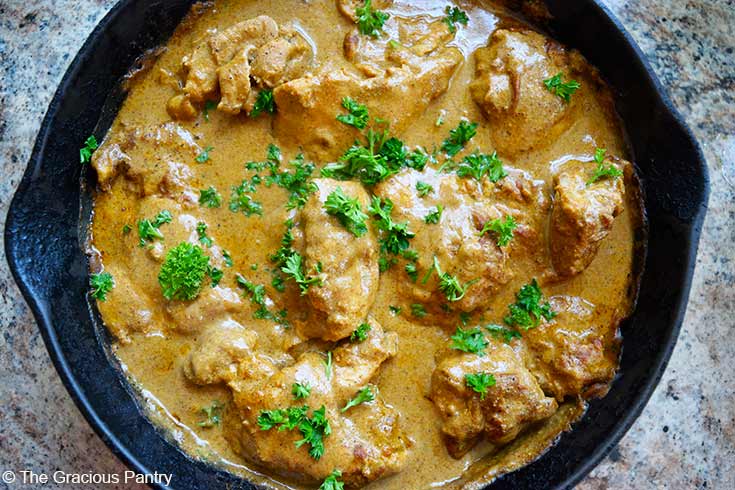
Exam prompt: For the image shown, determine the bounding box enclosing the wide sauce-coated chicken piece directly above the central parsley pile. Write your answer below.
[273,33,462,161]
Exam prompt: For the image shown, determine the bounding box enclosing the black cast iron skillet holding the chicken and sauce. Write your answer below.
[5,0,709,489]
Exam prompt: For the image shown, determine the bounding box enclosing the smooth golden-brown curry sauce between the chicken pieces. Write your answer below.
[92,0,641,489]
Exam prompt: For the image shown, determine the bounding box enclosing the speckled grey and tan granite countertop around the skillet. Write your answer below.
[0,0,735,489]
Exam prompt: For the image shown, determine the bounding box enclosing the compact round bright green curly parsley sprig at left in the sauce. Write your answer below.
[158,242,209,301]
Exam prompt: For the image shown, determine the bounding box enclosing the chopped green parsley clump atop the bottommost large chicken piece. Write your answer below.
[258,405,332,460]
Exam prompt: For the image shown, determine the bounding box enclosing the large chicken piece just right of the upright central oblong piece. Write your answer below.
[374,167,548,316]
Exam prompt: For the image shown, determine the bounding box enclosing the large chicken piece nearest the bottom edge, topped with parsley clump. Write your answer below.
[225,319,409,485]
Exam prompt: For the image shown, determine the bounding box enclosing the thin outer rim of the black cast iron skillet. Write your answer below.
[4,0,710,488]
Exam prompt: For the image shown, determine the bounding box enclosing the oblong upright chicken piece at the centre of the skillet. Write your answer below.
[298,179,379,341]
